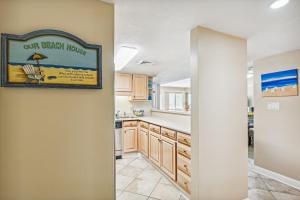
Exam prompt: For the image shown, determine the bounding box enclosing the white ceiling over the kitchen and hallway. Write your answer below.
[112,0,300,82]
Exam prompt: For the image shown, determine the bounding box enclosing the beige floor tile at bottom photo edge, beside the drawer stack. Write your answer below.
[150,183,181,200]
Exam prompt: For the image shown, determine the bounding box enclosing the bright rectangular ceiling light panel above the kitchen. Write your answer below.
[114,46,138,71]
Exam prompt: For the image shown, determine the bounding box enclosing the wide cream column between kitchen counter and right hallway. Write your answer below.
[191,27,248,200]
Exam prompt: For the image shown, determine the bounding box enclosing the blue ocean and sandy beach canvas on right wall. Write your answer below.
[261,69,298,97]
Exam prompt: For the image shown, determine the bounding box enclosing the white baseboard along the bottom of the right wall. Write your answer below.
[253,165,300,190]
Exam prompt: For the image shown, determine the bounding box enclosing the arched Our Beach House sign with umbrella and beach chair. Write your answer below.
[1,30,102,89]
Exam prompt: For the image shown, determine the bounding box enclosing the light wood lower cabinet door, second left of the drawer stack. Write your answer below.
[149,131,161,167]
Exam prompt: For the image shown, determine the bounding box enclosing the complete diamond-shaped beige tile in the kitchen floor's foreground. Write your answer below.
[125,179,158,196]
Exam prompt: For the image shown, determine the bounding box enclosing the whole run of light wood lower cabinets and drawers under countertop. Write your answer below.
[123,120,192,194]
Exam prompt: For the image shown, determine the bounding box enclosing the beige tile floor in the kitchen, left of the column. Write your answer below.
[116,153,187,200]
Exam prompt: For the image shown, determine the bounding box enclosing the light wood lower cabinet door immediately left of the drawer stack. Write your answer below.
[161,136,176,180]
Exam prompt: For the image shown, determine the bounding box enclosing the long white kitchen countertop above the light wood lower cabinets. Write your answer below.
[118,116,191,134]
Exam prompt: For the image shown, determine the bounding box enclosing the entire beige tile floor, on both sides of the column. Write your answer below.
[116,153,300,200]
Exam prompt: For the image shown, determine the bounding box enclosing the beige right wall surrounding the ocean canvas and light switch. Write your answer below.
[254,50,300,181]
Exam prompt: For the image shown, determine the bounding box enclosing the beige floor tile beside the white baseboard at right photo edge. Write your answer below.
[262,179,300,196]
